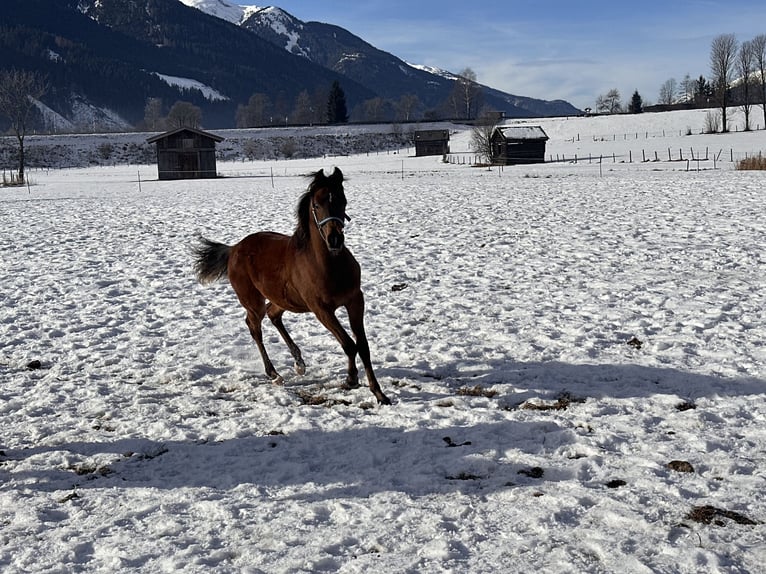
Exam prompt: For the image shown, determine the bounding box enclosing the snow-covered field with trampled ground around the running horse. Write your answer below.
[0,110,766,574]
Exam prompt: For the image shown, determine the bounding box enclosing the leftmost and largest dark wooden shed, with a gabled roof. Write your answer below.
[146,128,223,179]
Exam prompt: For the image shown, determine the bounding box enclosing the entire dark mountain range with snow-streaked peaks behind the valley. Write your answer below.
[0,0,577,130]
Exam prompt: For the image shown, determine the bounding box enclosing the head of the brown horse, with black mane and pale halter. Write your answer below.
[306,167,351,255]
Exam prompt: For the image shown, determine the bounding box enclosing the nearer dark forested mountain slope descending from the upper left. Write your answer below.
[0,0,375,127]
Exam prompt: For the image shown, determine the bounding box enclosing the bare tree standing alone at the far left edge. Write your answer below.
[0,70,48,183]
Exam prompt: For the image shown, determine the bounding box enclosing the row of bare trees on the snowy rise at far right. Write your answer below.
[596,34,766,132]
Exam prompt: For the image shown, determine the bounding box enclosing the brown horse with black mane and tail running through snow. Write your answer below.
[194,167,391,405]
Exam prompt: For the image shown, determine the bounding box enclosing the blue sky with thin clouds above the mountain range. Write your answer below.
[239,0,766,109]
